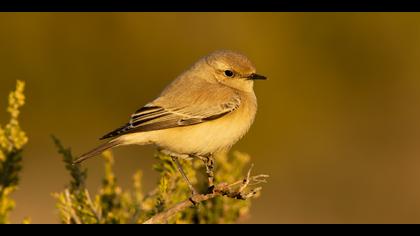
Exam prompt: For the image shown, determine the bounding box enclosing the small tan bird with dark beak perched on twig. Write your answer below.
[75,50,266,193]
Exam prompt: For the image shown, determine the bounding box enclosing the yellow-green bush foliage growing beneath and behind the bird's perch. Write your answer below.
[54,136,256,224]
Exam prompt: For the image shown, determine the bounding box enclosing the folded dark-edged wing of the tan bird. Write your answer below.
[101,93,241,139]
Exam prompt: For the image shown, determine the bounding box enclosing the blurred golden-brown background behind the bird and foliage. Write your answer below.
[0,13,420,223]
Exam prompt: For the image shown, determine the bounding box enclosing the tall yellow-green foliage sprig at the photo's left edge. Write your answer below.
[0,81,28,224]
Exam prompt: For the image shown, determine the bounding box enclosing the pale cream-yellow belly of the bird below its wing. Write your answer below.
[152,109,255,155]
